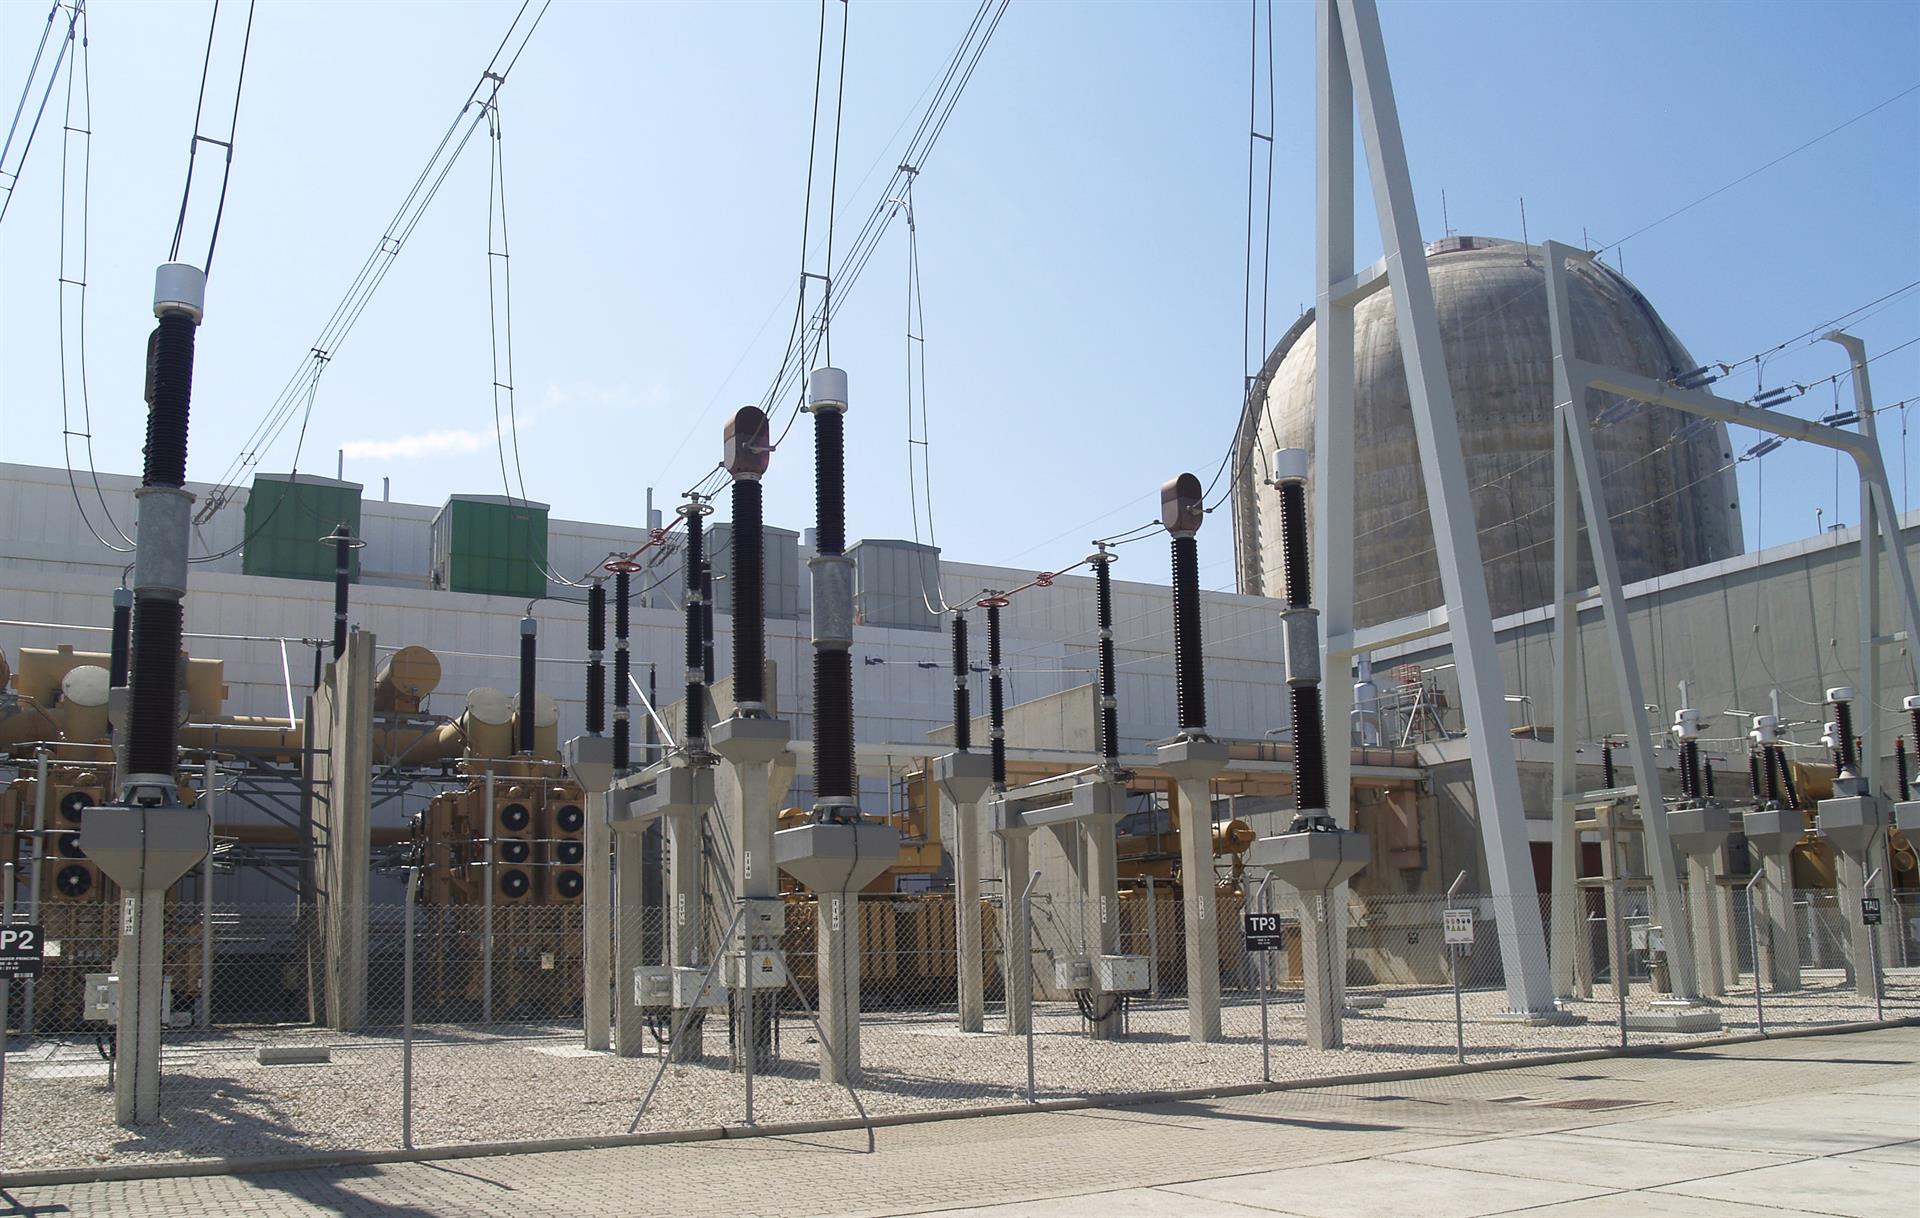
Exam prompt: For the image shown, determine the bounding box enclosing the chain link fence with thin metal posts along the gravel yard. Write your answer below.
[0,882,1920,1170]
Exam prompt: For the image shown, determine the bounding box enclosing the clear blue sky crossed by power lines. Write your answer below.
[0,0,1920,588]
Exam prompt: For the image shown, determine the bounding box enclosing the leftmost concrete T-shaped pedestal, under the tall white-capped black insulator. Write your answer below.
[78,805,211,1126]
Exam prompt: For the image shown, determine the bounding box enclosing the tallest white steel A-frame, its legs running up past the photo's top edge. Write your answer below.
[1313,0,1553,1014]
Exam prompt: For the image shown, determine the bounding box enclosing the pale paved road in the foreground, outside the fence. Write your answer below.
[0,1028,1920,1218]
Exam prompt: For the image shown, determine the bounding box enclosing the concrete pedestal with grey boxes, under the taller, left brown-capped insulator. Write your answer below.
[710,715,793,1070]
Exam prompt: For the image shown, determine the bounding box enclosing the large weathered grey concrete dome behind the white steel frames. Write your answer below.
[1235,236,1743,626]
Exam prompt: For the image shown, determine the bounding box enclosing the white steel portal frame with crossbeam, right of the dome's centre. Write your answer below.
[1546,242,1920,993]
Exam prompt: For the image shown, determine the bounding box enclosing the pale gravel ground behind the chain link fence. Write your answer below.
[0,970,1920,1170]
